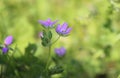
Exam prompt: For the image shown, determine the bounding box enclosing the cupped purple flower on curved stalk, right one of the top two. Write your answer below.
[56,23,72,36]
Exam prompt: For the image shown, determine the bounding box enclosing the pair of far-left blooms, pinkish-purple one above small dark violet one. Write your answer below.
[2,36,13,53]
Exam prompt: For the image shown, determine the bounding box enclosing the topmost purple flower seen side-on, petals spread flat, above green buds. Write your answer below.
[38,18,57,28]
